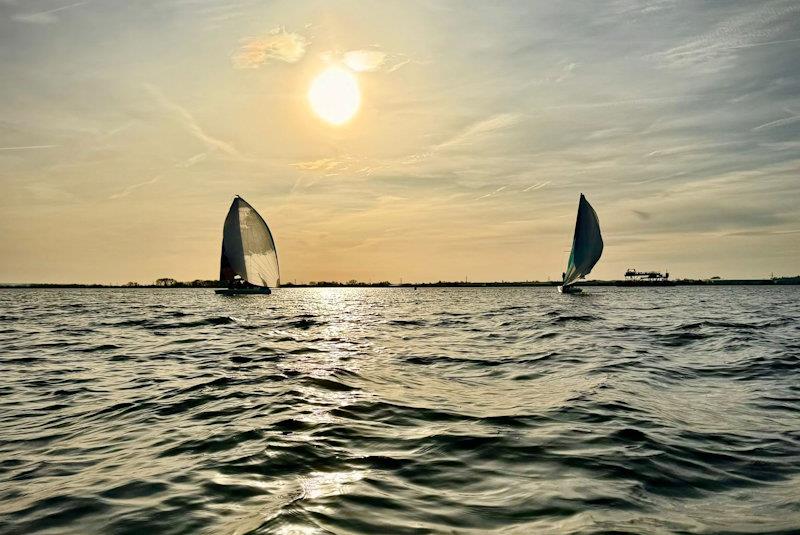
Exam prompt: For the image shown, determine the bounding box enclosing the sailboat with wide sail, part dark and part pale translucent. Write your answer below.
[216,195,281,295]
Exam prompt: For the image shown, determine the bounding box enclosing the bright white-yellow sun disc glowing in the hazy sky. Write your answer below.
[308,67,361,126]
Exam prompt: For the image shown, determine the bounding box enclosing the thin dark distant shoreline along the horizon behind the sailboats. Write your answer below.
[0,276,800,289]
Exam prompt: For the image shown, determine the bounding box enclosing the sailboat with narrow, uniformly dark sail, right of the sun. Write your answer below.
[558,193,603,293]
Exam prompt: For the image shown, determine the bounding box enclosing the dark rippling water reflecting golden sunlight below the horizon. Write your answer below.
[0,287,800,534]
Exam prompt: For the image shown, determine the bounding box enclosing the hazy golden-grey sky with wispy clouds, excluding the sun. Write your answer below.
[0,0,800,283]
